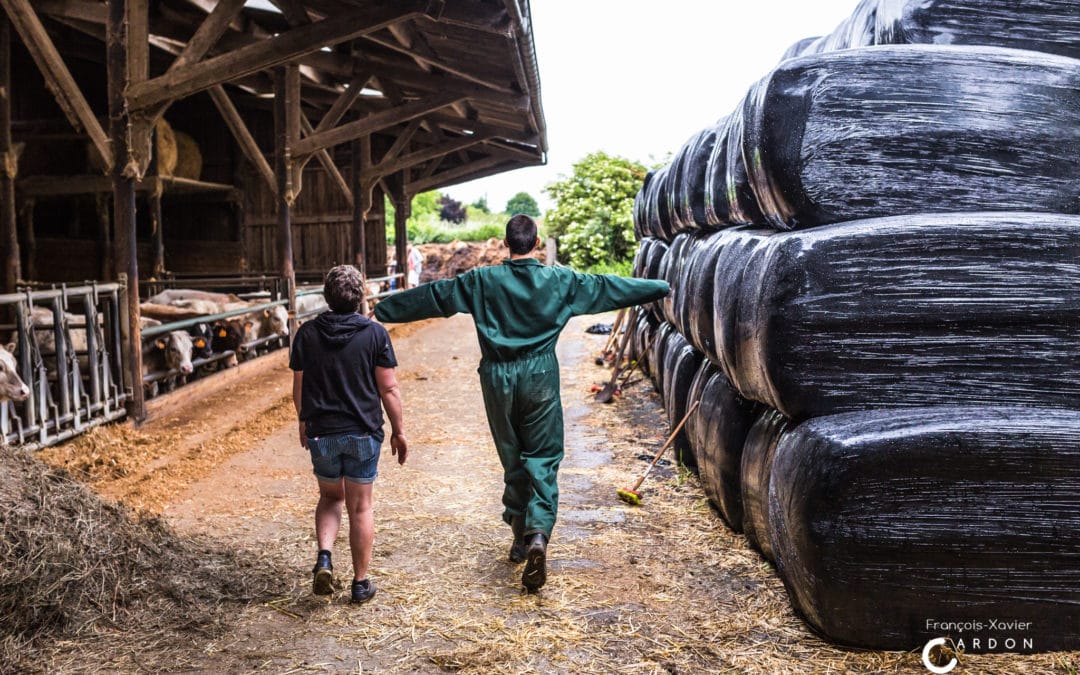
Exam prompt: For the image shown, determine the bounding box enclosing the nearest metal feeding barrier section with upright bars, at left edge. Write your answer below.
[0,283,127,447]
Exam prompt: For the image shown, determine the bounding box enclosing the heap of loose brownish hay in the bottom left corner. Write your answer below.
[0,447,280,672]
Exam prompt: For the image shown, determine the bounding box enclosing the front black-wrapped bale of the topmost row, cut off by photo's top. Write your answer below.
[875,0,1080,58]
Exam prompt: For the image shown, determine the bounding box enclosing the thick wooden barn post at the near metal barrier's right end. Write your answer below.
[106,0,146,423]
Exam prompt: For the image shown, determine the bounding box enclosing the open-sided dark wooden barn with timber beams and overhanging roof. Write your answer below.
[0,0,546,419]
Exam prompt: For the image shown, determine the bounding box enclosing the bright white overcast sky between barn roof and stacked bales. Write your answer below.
[442,0,858,211]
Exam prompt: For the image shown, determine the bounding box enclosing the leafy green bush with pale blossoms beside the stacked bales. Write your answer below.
[544,152,646,269]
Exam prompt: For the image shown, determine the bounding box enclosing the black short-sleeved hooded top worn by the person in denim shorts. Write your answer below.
[288,312,397,443]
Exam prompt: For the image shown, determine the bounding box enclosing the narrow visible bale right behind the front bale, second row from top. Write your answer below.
[704,104,765,229]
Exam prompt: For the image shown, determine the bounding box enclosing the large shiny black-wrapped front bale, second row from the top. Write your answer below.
[742,45,1080,229]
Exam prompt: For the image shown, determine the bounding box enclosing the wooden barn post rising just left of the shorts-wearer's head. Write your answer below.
[273,64,300,335]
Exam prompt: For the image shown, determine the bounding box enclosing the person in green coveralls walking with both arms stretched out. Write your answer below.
[375,214,669,592]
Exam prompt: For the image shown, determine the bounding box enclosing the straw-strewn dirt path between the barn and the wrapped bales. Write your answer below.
[78,316,1061,674]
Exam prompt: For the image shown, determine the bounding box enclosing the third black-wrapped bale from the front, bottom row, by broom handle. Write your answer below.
[687,361,762,532]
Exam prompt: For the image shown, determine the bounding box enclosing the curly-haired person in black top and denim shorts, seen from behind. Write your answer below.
[288,265,408,603]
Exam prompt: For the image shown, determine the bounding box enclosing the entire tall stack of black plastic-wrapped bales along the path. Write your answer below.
[634,0,1080,651]
